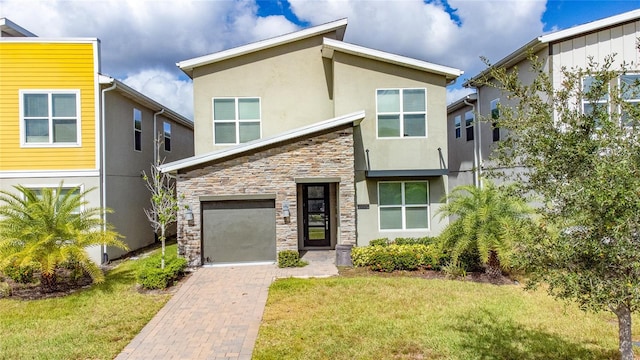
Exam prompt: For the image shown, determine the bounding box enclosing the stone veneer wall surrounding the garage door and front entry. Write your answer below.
[177,125,356,266]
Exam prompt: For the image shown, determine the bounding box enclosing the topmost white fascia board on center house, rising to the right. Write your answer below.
[176,19,347,74]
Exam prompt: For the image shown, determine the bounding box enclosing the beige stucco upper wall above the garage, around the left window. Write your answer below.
[193,33,335,155]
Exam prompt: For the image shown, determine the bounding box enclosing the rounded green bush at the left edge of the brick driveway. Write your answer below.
[136,256,187,289]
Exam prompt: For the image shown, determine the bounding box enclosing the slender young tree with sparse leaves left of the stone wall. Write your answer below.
[143,136,179,269]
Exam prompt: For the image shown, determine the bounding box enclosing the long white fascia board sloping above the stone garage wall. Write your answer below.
[160,111,365,173]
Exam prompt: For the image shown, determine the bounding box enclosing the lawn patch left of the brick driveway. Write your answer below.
[0,245,177,359]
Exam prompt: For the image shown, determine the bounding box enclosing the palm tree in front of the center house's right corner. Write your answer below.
[438,180,531,278]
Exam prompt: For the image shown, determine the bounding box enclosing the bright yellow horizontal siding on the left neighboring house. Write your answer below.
[0,42,97,171]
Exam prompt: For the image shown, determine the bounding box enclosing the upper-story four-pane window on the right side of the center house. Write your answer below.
[376,89,427,138]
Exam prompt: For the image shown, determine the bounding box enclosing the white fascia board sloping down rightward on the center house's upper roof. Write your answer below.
[322,38,464,79]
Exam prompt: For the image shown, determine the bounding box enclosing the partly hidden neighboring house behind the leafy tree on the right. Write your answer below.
[447,10,640,188]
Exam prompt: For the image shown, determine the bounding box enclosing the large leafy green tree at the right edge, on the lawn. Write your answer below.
[485,52,640,360]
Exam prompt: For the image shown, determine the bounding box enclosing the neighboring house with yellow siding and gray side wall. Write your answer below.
[0,19,193,263]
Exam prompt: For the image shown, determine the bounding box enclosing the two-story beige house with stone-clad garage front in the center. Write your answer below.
[163,20,462,265]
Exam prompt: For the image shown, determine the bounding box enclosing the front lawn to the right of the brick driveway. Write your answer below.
[253,277,640,360]
